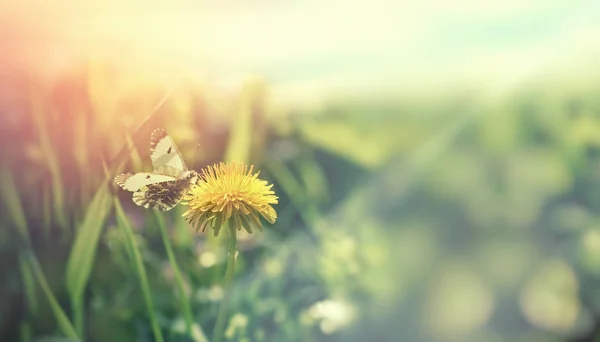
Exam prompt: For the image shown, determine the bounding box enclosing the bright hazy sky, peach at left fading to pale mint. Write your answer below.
[0,0,600,103]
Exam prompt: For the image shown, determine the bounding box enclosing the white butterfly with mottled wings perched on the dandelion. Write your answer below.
[115,128,198,211]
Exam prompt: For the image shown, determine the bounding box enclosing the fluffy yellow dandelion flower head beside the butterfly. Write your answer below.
[183,162,277,236]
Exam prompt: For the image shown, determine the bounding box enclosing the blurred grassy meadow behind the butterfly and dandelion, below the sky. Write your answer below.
[0,60,600,342]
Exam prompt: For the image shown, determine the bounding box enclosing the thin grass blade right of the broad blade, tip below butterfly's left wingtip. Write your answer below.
[114,196,163,342]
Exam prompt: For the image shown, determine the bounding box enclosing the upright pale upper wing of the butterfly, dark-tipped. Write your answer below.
[150,128,188,178]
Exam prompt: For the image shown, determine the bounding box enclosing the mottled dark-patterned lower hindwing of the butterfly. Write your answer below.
[133,179,190,211]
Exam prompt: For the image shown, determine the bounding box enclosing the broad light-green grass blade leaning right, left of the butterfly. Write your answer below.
[66,179,112,333]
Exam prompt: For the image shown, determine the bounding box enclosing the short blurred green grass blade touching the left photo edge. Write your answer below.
[0,168,31,244]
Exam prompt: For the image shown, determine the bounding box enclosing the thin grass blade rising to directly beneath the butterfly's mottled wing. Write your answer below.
[152,210,206,341]
